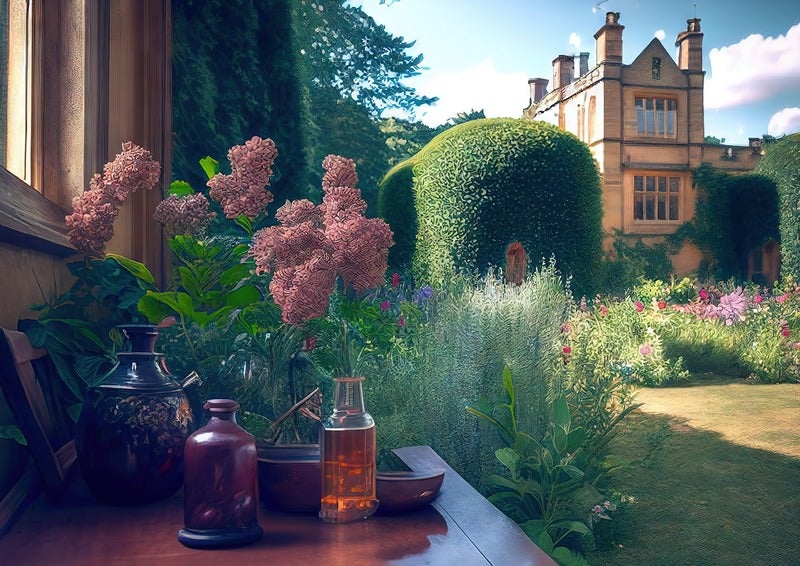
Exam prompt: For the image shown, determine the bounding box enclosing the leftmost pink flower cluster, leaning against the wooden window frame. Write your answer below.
[65,142,161,256]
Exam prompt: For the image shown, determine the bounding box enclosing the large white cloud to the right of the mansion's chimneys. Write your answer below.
[705,24,800,108]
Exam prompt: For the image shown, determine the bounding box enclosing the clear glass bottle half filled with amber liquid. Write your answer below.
[319,377,378,523]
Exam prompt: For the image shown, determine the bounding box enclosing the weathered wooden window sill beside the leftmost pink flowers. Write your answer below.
[0,167,76,256]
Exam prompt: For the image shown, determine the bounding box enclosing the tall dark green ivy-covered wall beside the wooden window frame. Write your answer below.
[172,0,314,202]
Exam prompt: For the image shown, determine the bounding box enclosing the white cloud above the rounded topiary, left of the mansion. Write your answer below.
[406,59,530,127]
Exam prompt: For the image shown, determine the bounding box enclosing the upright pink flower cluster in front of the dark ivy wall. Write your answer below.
[207,136,278,219]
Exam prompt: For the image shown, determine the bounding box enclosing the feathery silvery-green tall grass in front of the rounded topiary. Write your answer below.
[366,265,569,485]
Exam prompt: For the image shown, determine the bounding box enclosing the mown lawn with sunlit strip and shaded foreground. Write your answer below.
[587,379,800,566]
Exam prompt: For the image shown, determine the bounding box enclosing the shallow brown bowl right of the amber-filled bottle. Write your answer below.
[376,470,444,514]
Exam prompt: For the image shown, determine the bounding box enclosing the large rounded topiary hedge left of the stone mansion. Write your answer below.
[384,118,602,293]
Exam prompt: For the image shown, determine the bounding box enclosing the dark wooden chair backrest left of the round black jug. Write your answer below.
[0,329,76,495]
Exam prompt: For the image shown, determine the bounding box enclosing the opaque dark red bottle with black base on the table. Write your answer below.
[178,399,263,548]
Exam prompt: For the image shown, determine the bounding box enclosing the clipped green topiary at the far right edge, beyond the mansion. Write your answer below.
[756,133,800,281]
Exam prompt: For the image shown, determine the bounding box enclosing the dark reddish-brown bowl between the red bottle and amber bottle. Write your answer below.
[258,444,322,513]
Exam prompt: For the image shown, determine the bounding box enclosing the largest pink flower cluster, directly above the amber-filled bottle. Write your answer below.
[250,155,394,324]
